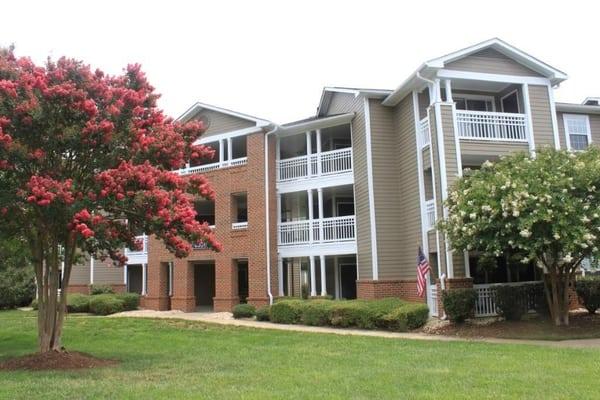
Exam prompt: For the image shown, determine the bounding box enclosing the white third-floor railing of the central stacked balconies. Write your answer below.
[277,147,352,182]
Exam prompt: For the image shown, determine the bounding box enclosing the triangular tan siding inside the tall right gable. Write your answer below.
[444,49,541,76]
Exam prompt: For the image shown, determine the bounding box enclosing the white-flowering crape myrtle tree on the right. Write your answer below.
[440,148,600,325]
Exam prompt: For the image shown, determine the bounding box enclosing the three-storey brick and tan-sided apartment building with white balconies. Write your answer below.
[70,39,600,315]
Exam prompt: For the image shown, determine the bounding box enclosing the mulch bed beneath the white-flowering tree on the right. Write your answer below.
[422,310,600,340]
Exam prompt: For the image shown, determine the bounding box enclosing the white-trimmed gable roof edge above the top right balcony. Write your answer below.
[383,38,568,106]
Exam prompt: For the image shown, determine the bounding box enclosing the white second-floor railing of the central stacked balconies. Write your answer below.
[278,215,356,246]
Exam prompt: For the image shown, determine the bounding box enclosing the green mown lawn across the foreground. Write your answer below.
[0,311,600,399]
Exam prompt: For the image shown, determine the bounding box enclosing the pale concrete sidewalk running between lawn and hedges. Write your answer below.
[110,310,600,349]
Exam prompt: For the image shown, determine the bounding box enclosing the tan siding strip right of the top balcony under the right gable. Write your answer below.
[529,85,554,149]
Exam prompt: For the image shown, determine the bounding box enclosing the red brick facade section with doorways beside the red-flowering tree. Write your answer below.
[142,133,277,311]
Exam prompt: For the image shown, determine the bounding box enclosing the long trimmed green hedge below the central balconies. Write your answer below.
[269,298,429,331]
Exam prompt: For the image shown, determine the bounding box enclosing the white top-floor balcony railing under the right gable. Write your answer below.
[456,110,527,142]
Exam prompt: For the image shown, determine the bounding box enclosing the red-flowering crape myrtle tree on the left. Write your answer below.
[0,49,220,352]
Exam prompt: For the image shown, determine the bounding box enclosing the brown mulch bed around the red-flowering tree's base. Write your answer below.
[0,351,119,371]
